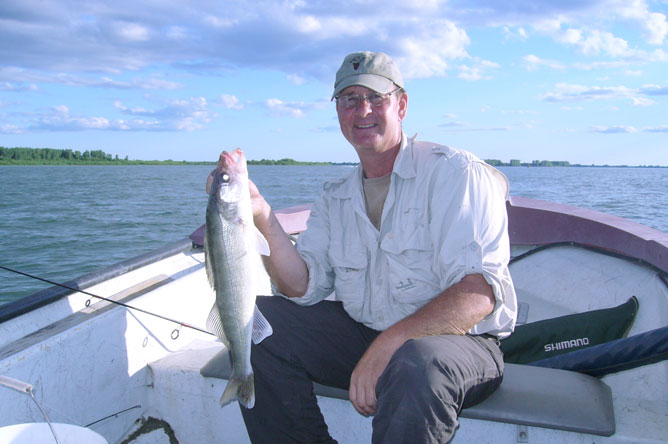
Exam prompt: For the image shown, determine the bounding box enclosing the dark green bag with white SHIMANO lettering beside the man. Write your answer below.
[501,296,638,364]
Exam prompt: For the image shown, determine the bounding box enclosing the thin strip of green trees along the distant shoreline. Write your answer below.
[0,146,668,168]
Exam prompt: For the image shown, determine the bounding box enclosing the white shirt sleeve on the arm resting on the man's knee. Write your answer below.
[430,161,517,337]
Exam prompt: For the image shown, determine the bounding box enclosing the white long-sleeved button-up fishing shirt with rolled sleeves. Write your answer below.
[282,134,517,338]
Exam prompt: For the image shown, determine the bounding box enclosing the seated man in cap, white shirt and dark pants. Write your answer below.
[209,52,517,444]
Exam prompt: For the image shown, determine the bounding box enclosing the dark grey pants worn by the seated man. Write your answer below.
[241,296,503,444]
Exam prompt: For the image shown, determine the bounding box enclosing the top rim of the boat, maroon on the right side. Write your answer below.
[5,196,668,323]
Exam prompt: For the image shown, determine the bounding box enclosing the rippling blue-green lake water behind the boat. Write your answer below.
[0,165,668,303]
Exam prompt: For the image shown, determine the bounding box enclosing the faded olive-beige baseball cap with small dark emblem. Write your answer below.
[332,51,404,99]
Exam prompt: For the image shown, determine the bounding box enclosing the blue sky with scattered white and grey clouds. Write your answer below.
[0,0,668,166]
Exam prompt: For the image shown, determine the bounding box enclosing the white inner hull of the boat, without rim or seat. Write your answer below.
[0,199,668,444]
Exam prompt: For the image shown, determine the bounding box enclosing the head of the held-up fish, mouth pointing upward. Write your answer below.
[211,148,250,219]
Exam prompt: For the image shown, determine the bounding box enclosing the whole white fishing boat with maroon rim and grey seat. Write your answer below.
[0,196,668,444]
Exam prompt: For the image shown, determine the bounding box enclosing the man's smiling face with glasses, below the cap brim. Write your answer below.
[336,86,408,154]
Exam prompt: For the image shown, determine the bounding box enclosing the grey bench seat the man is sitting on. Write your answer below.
[200,349,615,436]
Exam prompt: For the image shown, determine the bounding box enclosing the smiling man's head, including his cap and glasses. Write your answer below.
[333,52,408,158]
